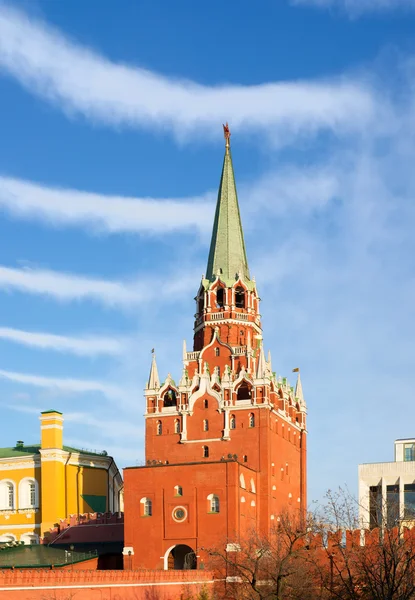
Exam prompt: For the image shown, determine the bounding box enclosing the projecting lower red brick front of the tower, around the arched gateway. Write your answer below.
[124,462,239,569]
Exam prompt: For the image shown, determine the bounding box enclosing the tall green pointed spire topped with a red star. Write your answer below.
[206,124,250,281]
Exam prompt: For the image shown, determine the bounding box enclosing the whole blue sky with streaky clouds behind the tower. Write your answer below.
[0,0,415,500]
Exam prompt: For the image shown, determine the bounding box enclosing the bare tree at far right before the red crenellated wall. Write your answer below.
[310,489,415,600]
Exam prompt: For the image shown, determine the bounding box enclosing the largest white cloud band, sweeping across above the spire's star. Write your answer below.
[0,4,375,140]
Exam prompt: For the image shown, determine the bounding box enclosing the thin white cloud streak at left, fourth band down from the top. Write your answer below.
[0,327,127,356]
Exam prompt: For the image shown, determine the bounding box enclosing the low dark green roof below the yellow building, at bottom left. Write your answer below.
[0,544,96,569]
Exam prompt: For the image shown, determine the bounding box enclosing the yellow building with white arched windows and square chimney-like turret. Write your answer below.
[0,410,123,544]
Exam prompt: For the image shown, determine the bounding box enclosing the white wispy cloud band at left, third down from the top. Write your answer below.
[0,266,197,308]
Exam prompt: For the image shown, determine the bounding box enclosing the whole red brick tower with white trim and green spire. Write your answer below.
[124,126,306,568]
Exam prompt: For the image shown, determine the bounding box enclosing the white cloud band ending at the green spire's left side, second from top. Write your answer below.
[0,176,213,234]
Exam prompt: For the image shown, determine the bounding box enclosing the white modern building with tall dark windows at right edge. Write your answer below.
[359,438,415,529]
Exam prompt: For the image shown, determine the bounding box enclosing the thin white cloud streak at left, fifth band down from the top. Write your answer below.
[0,370,126,398]
